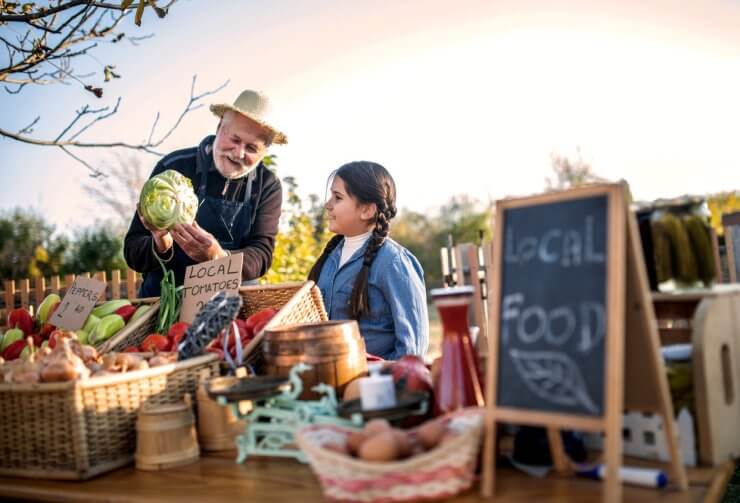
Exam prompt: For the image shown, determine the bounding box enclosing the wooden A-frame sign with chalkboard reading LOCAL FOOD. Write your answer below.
[482,184,686,501]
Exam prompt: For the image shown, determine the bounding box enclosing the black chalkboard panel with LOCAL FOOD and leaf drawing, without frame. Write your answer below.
[497,195,608,416]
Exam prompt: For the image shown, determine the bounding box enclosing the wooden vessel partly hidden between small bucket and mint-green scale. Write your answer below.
[196,384,247,451]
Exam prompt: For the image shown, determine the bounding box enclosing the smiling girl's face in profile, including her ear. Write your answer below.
[325,176,377,237]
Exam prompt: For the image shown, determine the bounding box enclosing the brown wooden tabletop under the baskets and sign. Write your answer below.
[0,452,734,503]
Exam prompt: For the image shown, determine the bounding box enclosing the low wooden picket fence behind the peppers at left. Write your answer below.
[0,269,141,327]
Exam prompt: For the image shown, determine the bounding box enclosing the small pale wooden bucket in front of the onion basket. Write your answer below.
[135,395,200,470]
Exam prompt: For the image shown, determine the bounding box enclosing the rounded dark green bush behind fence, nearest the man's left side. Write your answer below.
[62,225,126,274]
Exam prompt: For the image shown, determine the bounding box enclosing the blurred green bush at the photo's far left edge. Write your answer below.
[0,208,69,279]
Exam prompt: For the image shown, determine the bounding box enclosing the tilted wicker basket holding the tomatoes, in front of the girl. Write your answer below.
[239,281,329,370]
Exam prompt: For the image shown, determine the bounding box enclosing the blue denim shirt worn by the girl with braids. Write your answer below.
[317,238,429,360]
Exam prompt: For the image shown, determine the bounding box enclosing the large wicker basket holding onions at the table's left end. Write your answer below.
[0,354,218,480]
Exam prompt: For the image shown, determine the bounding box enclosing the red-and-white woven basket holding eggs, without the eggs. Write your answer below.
[296,408,483,503]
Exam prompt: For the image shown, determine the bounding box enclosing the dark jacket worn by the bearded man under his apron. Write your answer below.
[123,136,283,285]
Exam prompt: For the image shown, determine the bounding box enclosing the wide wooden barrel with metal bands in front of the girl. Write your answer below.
[262,320,367,400]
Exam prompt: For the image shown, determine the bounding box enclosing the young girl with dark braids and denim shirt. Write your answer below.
[308,161,429,360]
